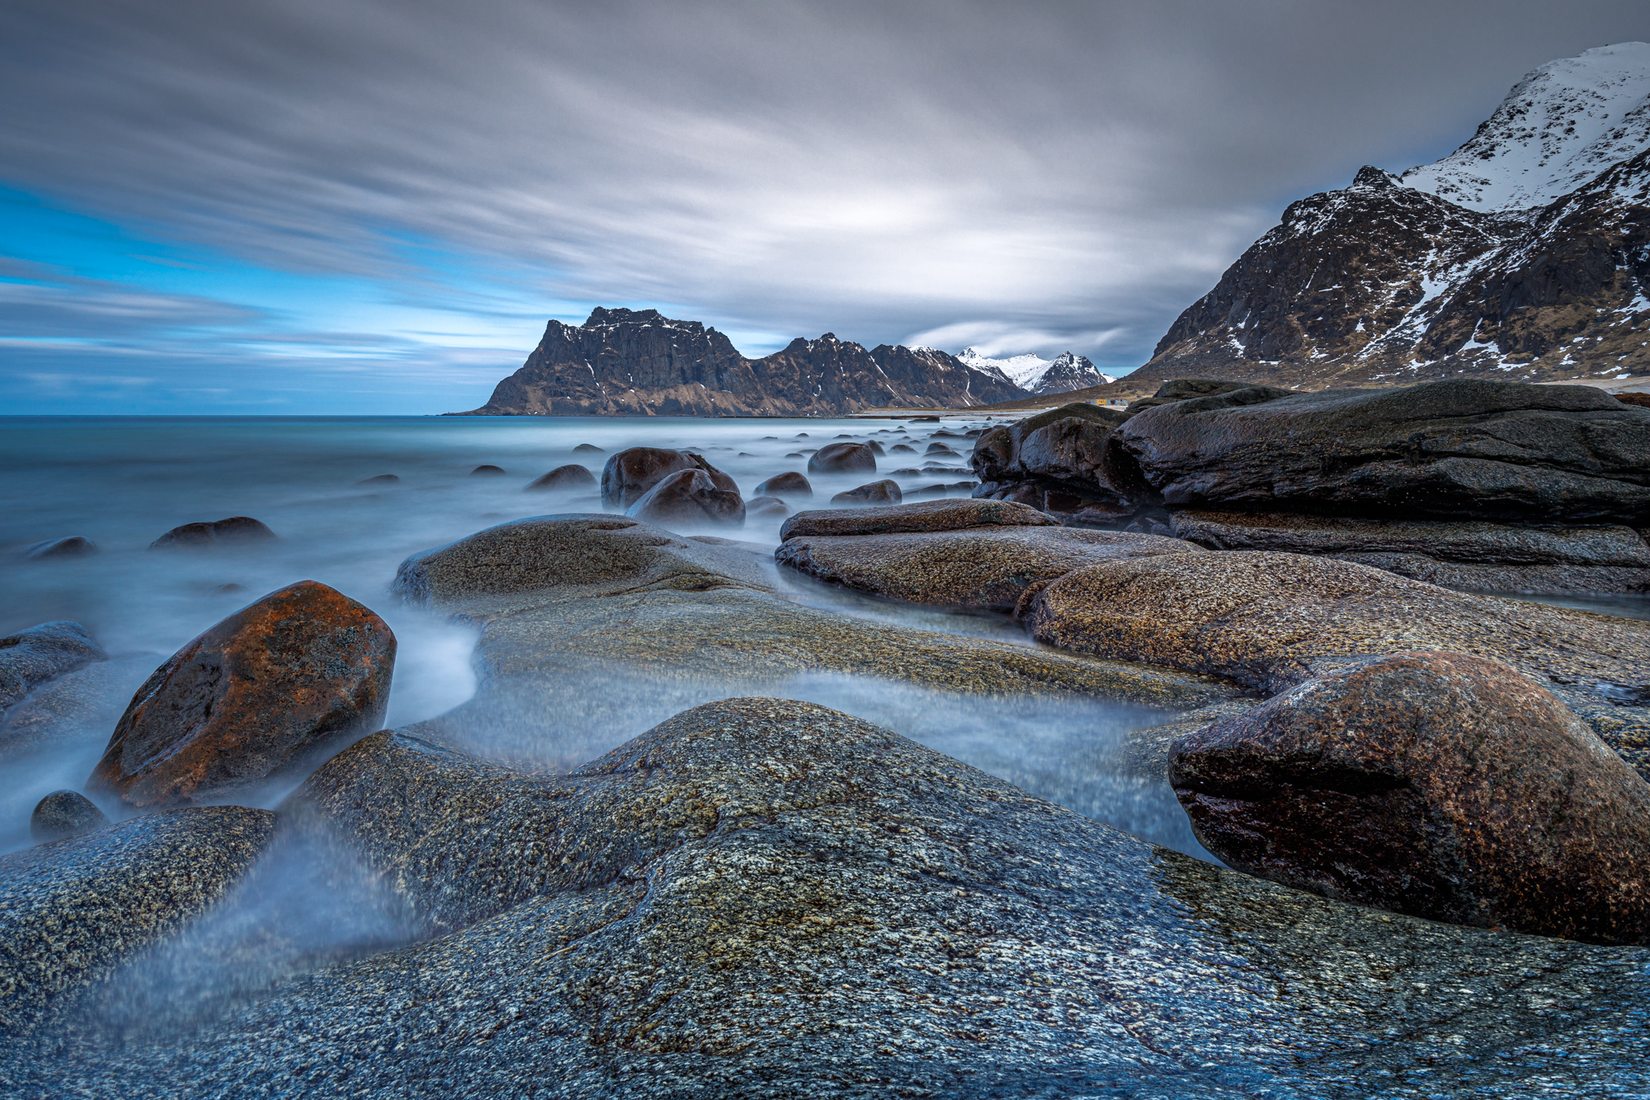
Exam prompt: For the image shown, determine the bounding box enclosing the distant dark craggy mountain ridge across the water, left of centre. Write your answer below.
[472,308,1025,416]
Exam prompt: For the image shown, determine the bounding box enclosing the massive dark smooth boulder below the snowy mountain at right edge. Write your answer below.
[1112,379,1650,524]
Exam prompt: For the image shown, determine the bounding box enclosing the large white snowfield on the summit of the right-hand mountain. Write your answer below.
[1399,41,1650,213]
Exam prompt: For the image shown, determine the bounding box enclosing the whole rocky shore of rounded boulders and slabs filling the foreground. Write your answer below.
[0,381,1650,1097]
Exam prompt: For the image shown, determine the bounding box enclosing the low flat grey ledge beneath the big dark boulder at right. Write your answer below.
[1172,510,1650,592]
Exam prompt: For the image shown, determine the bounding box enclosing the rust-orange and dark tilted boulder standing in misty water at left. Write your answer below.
[89,581,396,806]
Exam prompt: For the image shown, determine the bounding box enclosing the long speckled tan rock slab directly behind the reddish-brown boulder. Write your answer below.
[1025,551,1650,775]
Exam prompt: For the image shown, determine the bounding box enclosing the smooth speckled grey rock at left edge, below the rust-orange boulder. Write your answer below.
[0,806,274,1046]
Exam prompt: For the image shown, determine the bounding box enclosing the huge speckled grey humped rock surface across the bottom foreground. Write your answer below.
[12,699,1650,1097]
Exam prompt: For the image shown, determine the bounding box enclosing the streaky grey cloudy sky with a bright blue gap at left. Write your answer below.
[0,0,1650,414]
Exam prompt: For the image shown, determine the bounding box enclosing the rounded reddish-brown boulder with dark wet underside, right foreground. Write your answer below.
[1170,653,1650,943]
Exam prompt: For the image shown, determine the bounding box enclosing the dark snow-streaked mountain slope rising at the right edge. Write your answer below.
[1129,43,1650,388]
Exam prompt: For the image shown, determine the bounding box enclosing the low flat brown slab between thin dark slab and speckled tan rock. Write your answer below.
[774,524,1198,612]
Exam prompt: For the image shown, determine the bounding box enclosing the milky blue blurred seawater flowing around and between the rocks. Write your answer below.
[0,410,1206,1032]
